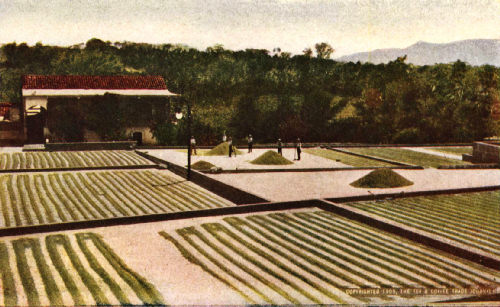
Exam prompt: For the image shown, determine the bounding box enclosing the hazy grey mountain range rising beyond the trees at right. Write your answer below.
[335,39,500,67]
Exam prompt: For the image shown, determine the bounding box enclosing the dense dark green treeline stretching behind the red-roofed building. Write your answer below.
[0,39,500,143]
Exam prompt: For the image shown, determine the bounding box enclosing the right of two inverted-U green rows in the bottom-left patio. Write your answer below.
[45,234,110,305]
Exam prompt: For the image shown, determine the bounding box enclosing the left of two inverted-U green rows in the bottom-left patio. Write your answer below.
[12,238,63,306]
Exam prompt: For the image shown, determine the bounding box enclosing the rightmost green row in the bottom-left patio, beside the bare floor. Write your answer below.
[78,233,164,305]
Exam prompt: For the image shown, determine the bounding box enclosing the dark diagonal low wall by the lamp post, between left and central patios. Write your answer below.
[136,150,268,205]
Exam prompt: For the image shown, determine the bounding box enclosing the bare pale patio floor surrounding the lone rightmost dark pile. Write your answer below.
[205,169,500,201]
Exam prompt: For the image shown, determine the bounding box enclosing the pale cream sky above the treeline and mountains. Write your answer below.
[0,0,500,57]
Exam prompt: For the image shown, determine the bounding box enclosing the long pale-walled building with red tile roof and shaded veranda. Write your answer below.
[22,75,180,143]
